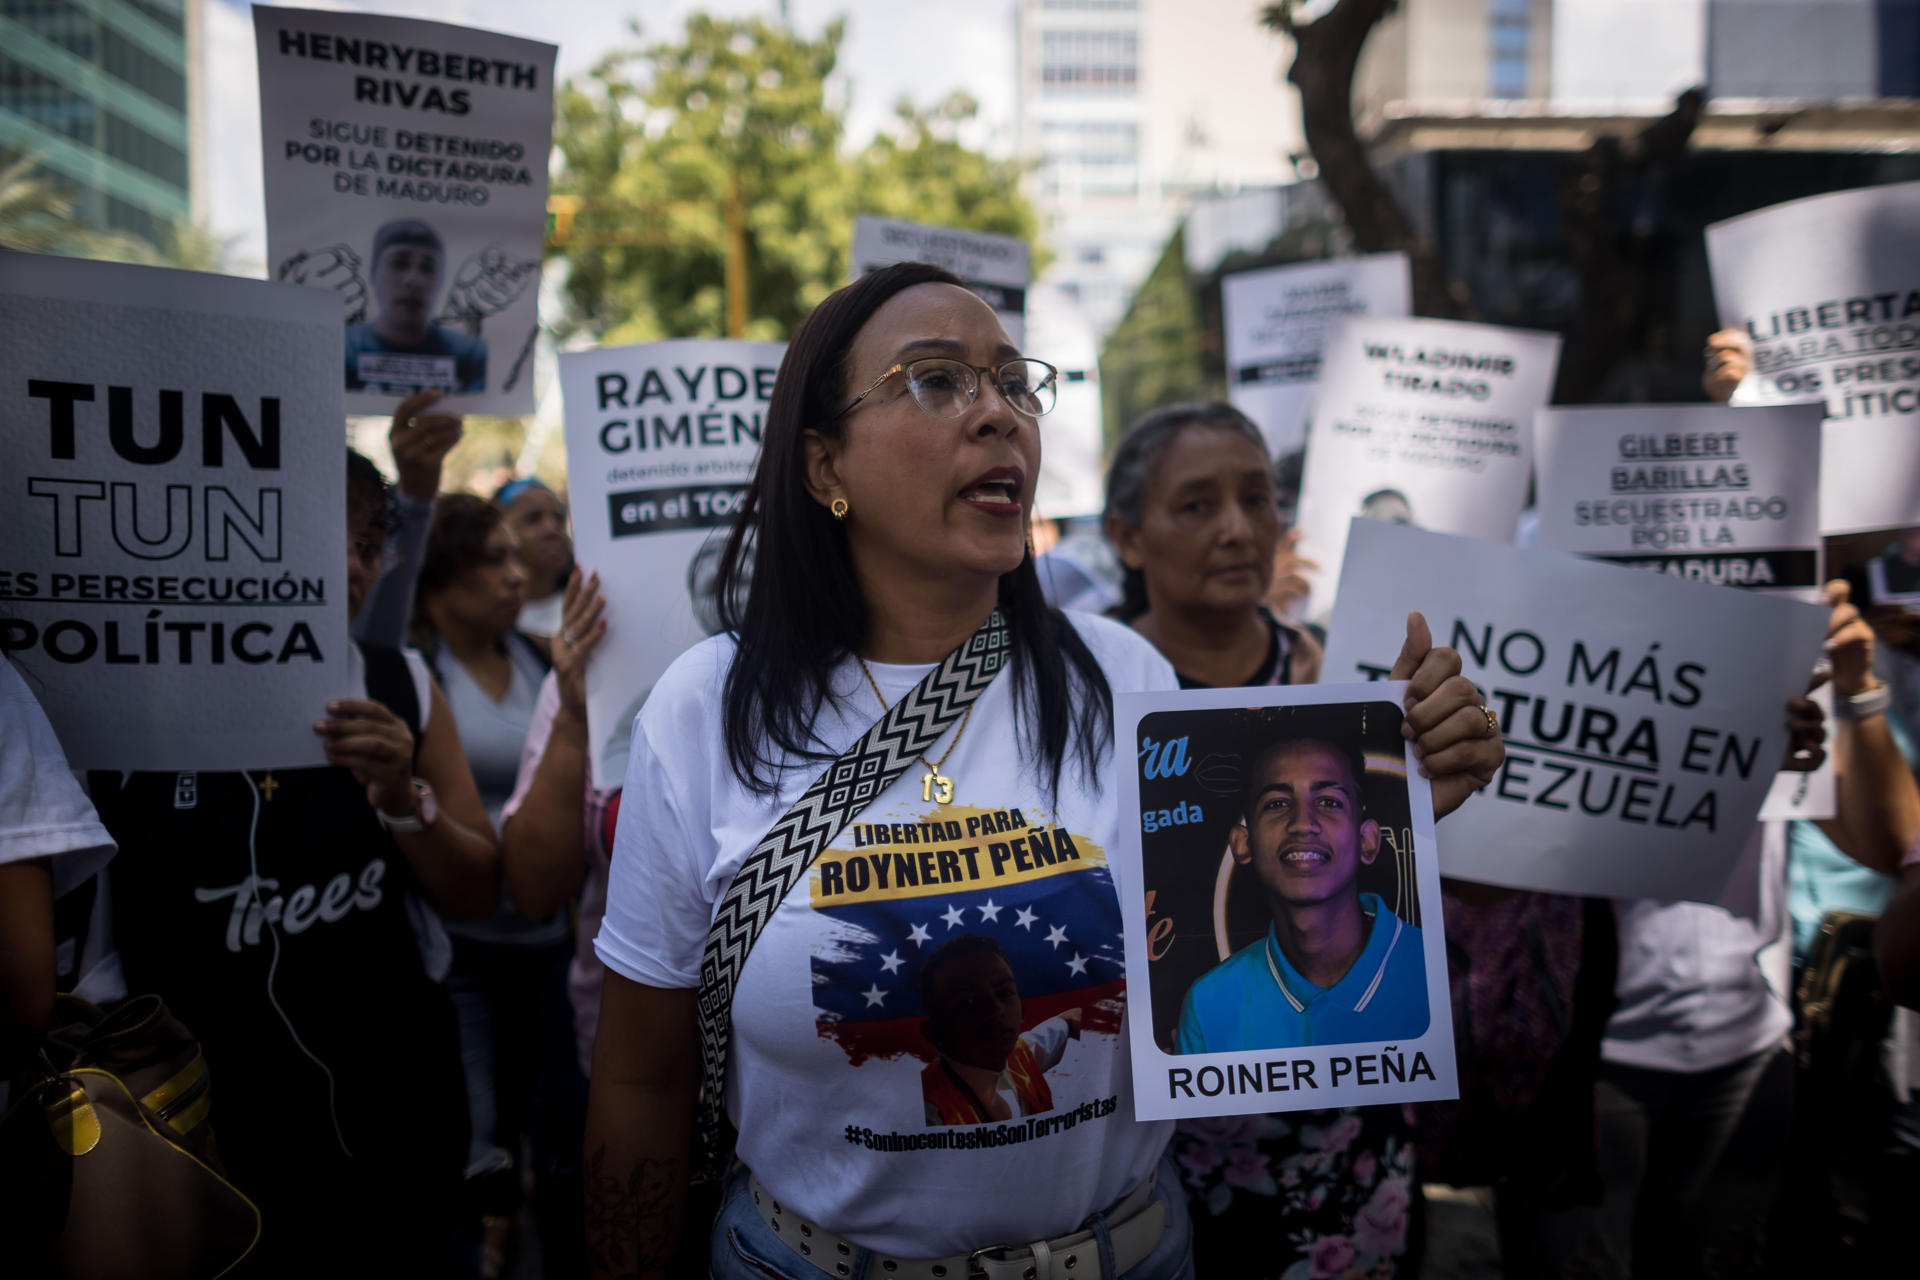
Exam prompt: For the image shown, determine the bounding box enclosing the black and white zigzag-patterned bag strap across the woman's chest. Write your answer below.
[693,608,1008,1176]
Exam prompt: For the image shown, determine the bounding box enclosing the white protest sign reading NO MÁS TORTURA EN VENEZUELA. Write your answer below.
[1325,520,1828,902]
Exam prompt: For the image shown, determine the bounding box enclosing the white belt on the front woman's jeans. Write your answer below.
[747,1174,1167,1280]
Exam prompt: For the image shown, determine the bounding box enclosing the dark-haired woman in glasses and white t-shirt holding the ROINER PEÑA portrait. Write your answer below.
[588,263,1484,1280]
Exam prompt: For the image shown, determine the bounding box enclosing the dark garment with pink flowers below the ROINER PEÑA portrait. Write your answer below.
[1173,1105,1419,1280]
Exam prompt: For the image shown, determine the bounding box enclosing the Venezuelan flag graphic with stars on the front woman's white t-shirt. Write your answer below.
[808,806,1125,1125]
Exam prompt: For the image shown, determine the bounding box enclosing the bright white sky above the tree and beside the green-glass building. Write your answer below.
[204,0,1016,274]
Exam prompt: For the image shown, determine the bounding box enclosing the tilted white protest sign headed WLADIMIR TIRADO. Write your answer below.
[1300,319,1559,618]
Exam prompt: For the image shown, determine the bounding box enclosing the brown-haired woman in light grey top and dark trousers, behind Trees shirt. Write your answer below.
[413,493,586,1276]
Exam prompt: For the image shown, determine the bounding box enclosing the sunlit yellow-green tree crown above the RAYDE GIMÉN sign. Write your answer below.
[549,15,1037,342]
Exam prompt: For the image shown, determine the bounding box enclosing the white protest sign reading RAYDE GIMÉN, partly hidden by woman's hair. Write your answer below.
[561,340,785,787]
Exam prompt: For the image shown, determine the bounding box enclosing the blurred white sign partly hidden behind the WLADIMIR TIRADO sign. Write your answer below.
[1219,253,1413,455]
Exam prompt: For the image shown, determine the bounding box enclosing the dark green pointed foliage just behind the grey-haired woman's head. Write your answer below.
[1100,226,1223,445]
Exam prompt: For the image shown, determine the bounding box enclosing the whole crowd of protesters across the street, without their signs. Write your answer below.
[0,265,1920,1280]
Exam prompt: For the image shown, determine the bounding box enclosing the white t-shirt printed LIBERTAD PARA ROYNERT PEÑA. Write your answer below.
[595,614,1177,1257]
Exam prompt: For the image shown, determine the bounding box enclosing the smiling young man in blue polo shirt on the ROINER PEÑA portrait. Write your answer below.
[1179,737,1430,1054]
